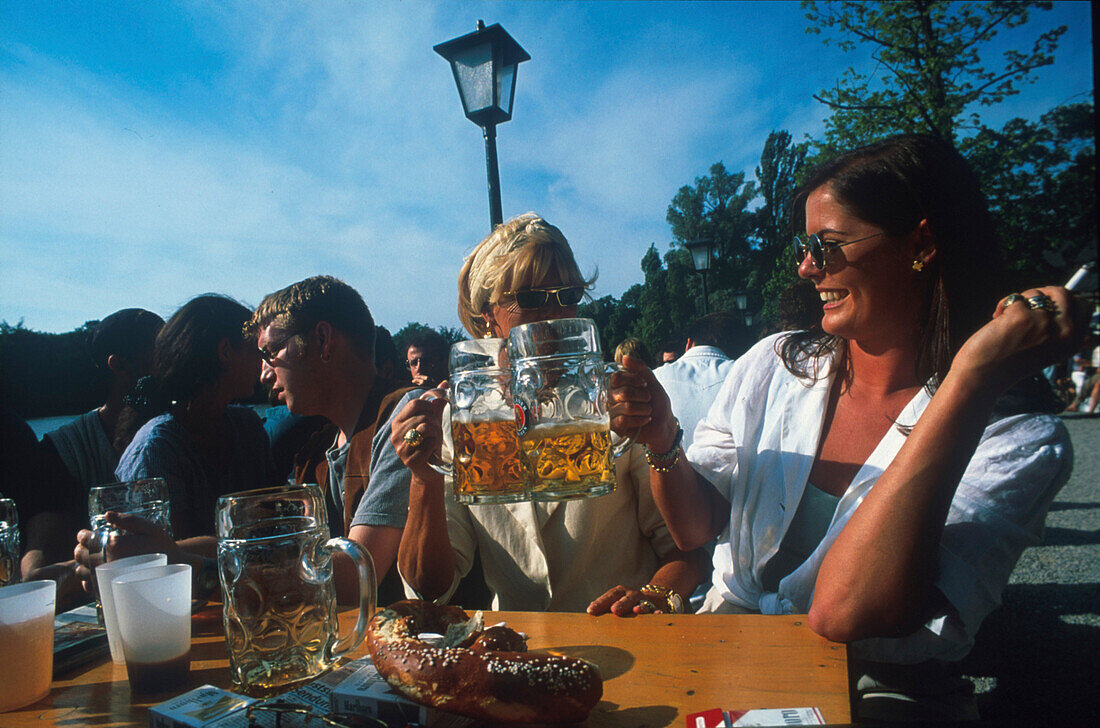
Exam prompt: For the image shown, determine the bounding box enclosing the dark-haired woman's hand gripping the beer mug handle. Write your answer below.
[608,355,677,452]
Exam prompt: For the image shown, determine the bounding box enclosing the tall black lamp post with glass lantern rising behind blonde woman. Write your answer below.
[433,20,531,230]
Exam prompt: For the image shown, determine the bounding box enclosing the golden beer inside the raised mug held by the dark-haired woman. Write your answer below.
[519,420,615,500]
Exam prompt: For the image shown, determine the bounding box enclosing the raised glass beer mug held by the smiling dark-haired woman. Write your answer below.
[508,319,633,500]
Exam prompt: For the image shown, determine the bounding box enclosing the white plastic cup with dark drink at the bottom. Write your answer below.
[111,564,191,694]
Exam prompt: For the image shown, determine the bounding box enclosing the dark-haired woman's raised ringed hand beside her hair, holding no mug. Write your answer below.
[952,286,1088,390]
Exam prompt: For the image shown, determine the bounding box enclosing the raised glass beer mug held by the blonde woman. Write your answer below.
[432,339,528,505]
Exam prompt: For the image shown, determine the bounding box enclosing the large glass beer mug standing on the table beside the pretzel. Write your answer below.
[216,485,375,695]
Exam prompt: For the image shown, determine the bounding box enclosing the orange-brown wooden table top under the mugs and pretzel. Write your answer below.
[0,611,850,728]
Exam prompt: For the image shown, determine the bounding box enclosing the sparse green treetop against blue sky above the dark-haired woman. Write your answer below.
[802,0,1066,151]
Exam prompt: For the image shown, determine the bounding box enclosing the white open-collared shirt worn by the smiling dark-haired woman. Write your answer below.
[688,334,1073,663]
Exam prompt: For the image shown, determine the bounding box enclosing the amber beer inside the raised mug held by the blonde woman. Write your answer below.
[451,417,527,504]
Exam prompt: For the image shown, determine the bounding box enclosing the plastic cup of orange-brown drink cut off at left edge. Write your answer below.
[0,581,57,713]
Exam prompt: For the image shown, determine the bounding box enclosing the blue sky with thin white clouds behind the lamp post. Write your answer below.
[0,0,1093,332]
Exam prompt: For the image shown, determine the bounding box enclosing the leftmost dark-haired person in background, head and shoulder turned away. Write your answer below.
[45,308,164,489]
